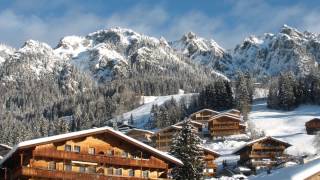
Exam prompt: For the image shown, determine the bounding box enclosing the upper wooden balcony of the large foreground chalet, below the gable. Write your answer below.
[32,149,167,169]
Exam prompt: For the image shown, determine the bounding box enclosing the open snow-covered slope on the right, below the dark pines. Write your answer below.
[249,101,320,155]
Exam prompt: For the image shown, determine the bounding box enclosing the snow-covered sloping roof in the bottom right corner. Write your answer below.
[250,157,320,180]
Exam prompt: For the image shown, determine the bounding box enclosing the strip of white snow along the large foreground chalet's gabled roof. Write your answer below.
[0,127,183,166]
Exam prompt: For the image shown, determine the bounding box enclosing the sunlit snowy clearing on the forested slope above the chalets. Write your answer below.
[123,90,194,128]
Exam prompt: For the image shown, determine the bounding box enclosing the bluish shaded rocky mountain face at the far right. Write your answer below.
[232,25,320,78]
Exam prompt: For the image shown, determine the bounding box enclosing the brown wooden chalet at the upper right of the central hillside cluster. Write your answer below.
[208,113,245,137]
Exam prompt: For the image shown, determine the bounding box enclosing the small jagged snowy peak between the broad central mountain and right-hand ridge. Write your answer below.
[170,32,232,72]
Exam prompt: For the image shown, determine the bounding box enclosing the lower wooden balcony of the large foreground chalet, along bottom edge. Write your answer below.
[13,167,166,180]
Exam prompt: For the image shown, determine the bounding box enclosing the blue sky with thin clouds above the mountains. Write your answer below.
[0,0,320,49]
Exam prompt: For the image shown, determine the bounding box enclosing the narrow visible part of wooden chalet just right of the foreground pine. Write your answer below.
[202,147,221,178]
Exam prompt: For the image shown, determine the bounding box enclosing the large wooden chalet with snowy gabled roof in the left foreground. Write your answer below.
[0,127,182,180]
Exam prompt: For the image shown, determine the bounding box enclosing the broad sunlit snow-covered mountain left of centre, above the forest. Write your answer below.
[55,28,225,81]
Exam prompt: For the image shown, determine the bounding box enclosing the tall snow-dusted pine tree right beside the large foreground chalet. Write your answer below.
[170,120,204,180]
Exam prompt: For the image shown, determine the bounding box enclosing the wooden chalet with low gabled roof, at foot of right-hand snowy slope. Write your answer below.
[234,136,291,168]
